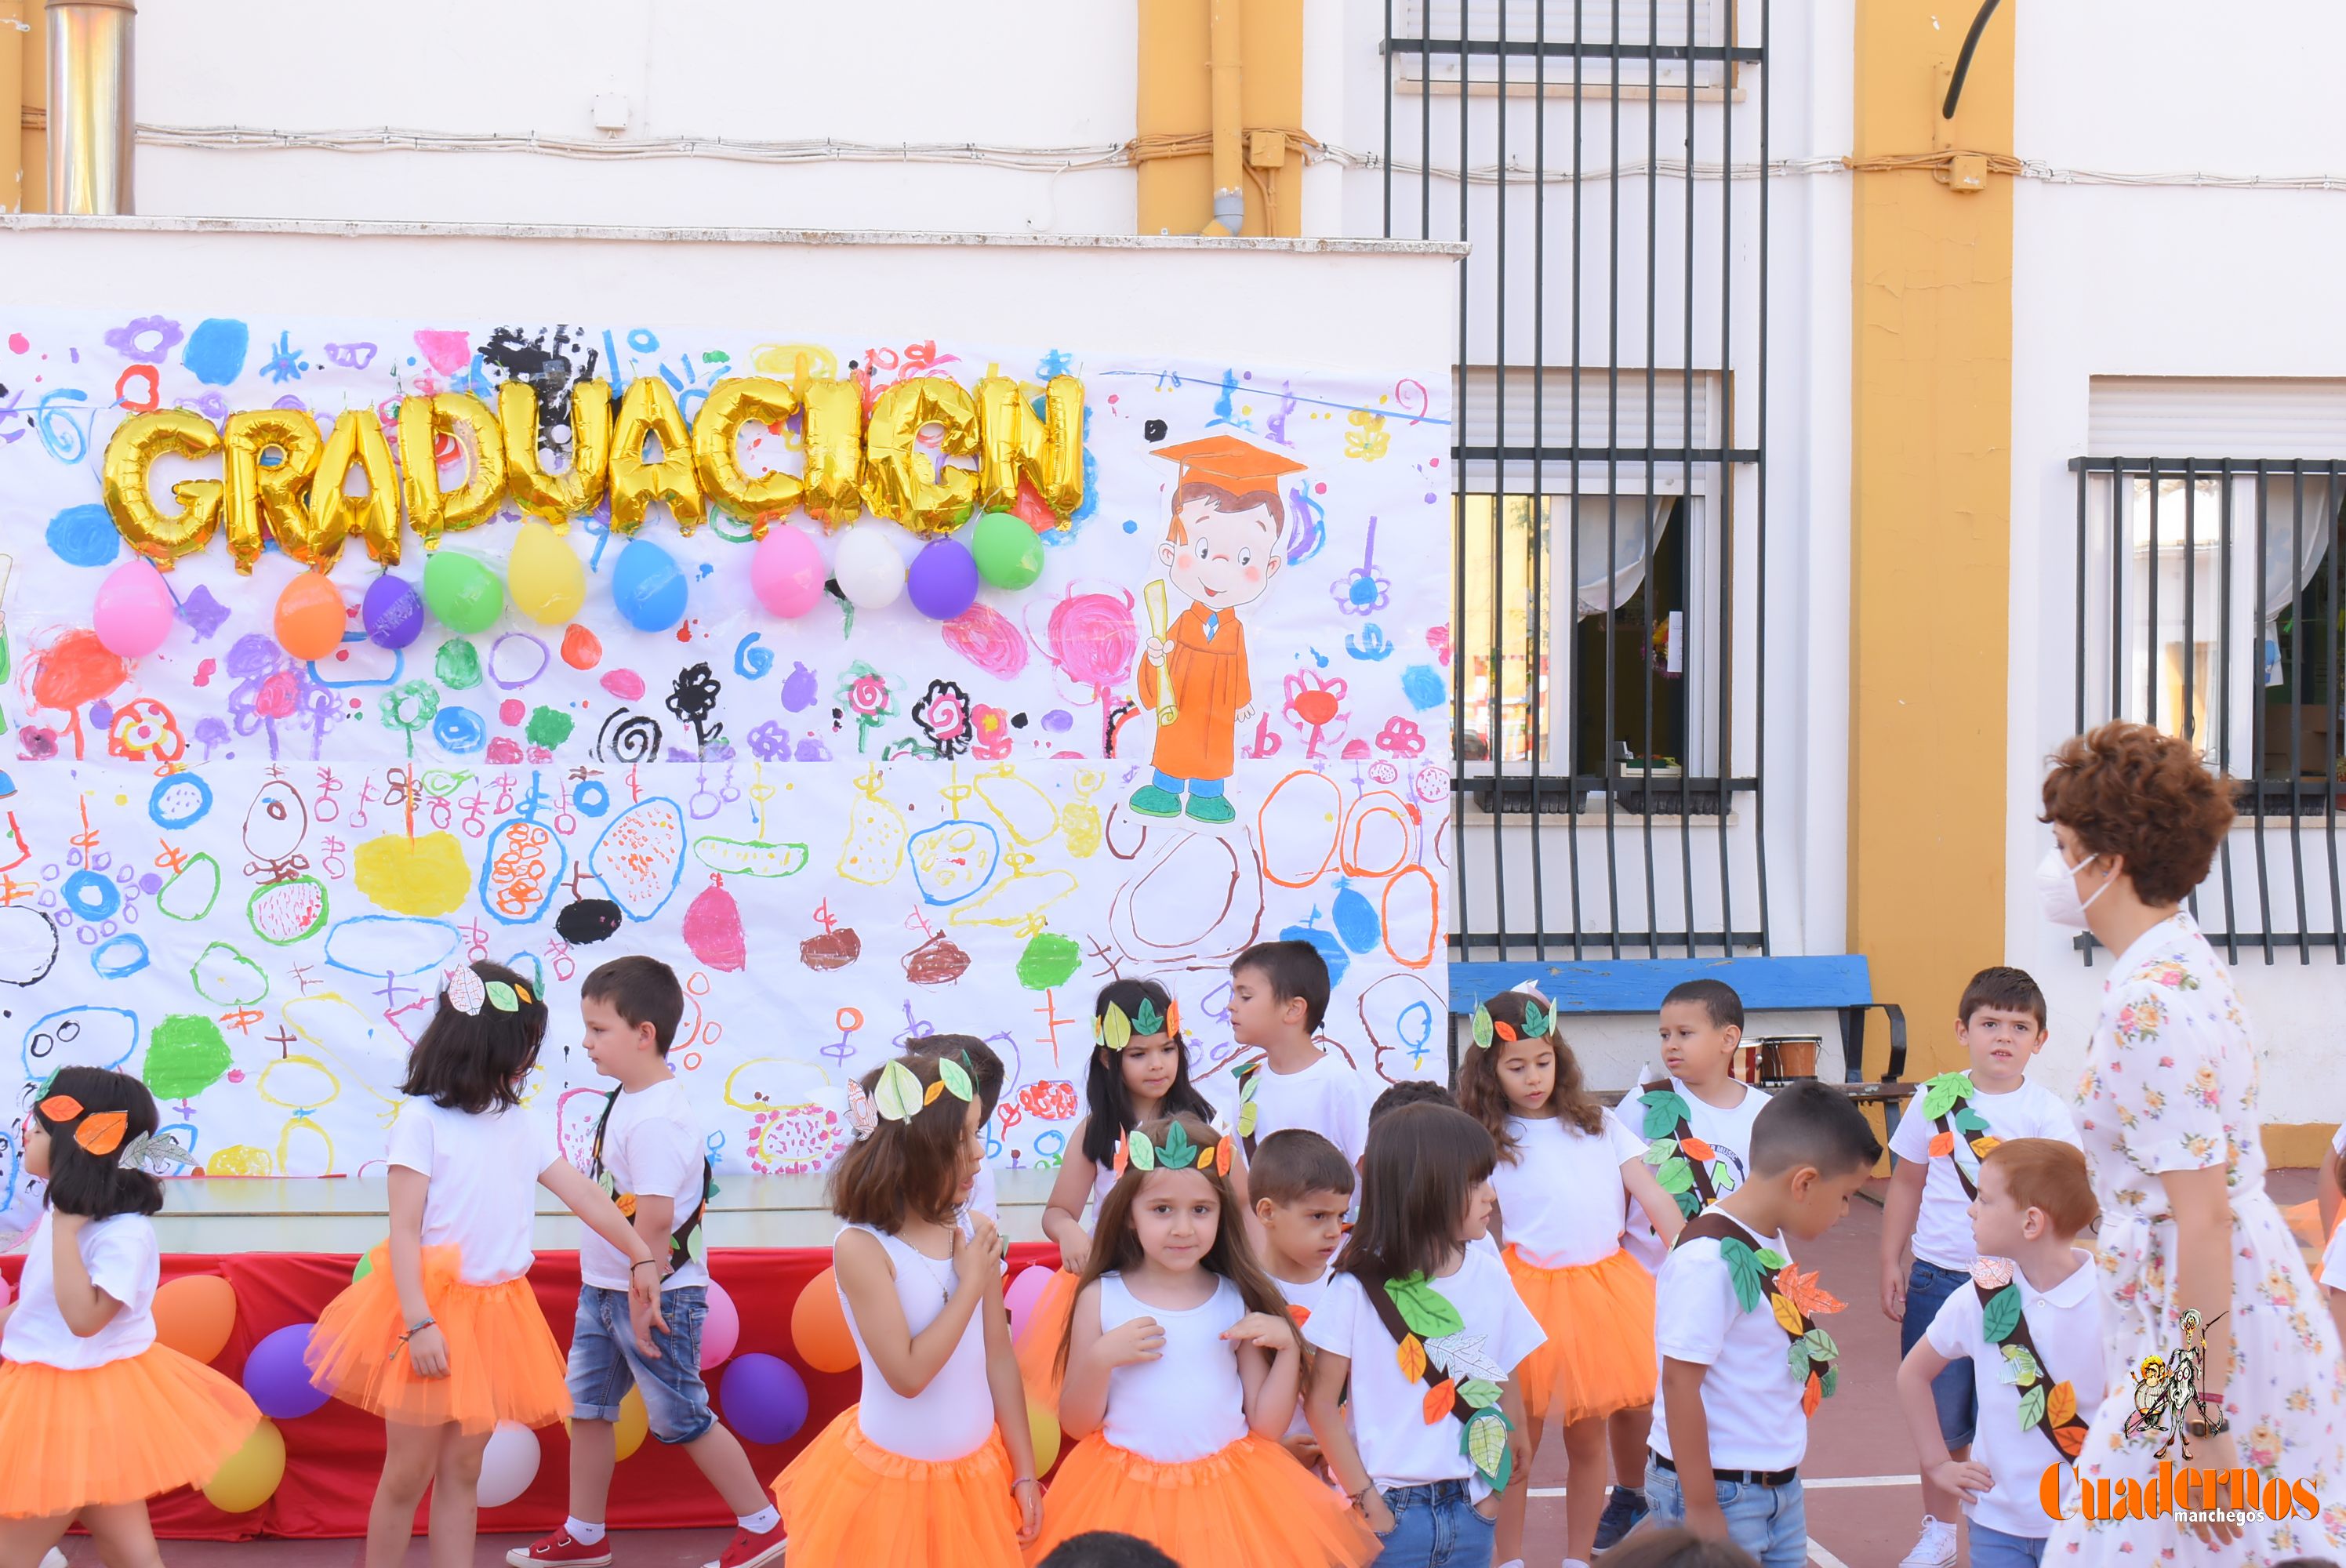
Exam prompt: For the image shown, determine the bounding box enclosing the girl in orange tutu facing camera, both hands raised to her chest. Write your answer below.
[1030,1115,1377,1568]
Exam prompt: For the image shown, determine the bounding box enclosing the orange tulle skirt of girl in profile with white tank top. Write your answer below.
[774,1406,1023,1568]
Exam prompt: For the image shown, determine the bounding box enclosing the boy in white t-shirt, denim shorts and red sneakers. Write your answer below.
[504,953,786,1568]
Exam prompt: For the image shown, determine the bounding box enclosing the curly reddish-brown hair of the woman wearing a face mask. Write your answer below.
[2039,723,2231,906]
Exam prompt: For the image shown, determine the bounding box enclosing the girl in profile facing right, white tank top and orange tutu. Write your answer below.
[774,1035,1041,1568]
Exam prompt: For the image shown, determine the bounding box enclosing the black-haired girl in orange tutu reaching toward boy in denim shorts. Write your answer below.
[307,963,666,1568]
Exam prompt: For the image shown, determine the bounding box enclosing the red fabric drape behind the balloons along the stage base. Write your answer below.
[0,1242,1058,1540]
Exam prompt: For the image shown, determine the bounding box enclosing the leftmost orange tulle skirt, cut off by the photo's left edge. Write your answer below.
[0,1345,260,1519]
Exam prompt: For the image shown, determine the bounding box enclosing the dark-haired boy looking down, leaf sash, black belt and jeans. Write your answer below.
[1644,1082,1882,1568]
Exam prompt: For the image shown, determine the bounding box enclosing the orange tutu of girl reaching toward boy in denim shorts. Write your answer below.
[307,1244,570,1432]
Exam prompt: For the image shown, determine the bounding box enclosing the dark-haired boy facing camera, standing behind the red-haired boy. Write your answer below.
[1882,967,2079,1568]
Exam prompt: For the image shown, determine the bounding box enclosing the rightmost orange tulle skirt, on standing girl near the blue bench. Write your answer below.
[1506,1247,1654,1425]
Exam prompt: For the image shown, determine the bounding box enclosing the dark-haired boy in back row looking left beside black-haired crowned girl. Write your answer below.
[1225,942,1367,1162]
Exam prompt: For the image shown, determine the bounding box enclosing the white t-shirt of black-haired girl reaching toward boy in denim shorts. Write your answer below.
[387,1094,563,1284]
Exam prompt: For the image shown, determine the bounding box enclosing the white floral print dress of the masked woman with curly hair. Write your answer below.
[2046,913,2346,1568]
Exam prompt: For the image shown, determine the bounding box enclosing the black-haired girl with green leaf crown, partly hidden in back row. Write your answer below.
[1019,981,1246,1408]
